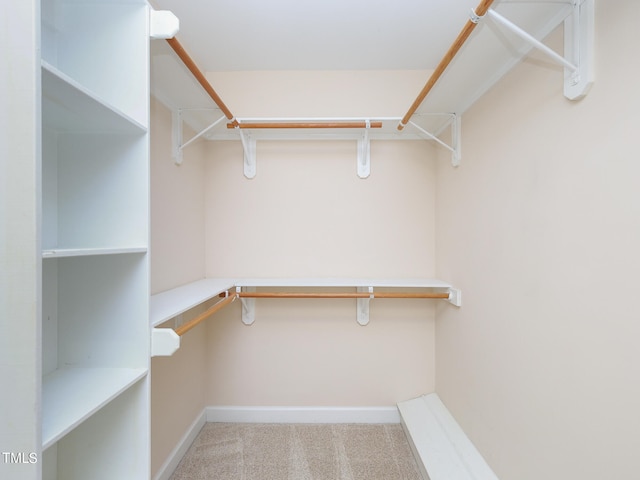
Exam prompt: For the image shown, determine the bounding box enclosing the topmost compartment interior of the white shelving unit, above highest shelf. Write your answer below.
[42,0,149,126]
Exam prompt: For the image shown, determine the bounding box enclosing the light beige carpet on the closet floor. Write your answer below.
[171,423,422,480]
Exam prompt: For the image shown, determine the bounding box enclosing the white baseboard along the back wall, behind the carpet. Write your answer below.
[205,406,400,423]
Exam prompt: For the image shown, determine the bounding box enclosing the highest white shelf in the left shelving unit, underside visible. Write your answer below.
[42,61,147,134]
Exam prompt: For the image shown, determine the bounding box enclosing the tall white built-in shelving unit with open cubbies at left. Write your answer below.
[40,0,150,480]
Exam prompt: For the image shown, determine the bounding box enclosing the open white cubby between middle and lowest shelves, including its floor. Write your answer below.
[42,248,150,449]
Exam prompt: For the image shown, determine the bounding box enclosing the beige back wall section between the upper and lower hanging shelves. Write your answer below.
[205,141,435,278]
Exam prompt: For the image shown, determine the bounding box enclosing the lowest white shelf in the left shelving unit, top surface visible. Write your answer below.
[42,368,147,450]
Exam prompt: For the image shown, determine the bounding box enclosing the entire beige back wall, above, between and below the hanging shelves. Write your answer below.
[200,68,435,406]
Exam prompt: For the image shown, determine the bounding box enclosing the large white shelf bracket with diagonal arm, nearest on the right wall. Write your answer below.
[487,0,594,100]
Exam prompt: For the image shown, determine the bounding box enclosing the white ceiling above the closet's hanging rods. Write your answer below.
[151,0,477,71]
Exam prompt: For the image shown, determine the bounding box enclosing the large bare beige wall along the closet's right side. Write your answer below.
[436,0,640,480]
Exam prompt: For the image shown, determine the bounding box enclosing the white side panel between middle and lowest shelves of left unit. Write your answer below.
[56,254,150,368]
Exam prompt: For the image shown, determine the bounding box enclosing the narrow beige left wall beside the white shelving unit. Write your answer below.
[151,99,206,476]
